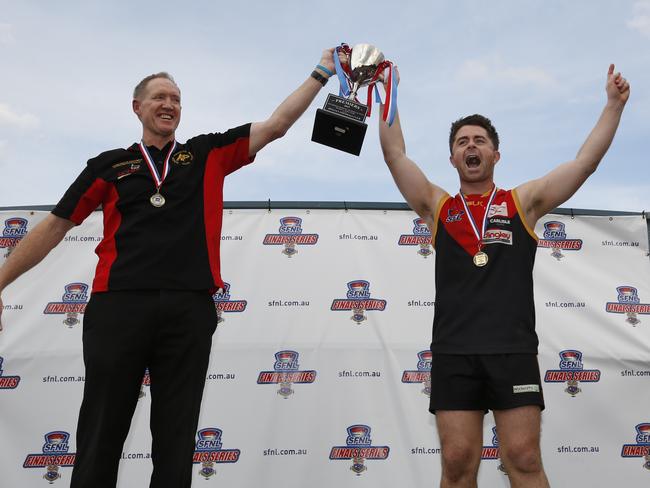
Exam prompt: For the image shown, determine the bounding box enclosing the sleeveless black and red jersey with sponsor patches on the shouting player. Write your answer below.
[431,189,538,354]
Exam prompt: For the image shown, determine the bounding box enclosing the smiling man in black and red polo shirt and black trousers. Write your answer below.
[0,49,334,488]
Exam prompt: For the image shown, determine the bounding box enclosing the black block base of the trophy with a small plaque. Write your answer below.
[311,108,368,156]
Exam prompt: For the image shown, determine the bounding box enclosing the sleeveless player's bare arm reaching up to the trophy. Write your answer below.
[379,110,445,224]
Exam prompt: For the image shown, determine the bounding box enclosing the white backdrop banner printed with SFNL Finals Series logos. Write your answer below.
[0,209,650,488]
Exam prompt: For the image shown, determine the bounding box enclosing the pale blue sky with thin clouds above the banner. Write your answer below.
[0,0,650,211]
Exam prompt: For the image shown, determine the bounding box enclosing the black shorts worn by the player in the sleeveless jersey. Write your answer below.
[429,354,544,413]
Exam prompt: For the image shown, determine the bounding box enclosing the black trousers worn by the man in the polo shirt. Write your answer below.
[70,290,217,488]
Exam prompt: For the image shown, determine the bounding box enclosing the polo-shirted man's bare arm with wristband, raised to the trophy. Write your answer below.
[248,48,334,156]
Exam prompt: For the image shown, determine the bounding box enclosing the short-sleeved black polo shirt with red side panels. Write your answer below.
[52,124,254,292]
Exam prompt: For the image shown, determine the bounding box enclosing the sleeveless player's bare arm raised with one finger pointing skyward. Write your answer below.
[517,64,630,228]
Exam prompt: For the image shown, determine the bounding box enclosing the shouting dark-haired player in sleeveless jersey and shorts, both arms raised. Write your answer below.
[379,65,630,488]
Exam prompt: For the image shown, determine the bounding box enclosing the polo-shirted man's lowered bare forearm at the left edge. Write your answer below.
[0,214,75,330]
